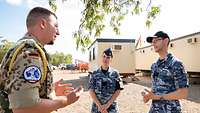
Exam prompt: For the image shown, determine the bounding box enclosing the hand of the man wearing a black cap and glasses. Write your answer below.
[141,89,154,103]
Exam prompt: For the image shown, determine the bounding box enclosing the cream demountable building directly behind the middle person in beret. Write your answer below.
[88,38,135,76]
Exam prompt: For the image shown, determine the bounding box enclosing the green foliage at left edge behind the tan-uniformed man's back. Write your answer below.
[0,40,14,62]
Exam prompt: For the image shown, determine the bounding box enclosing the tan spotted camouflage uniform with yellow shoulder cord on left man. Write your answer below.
[0,34,53,113]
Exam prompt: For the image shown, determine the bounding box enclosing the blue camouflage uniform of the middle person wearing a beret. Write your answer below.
[89,67,123,113]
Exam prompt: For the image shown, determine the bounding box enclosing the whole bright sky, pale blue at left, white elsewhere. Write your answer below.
[0,0,200,61]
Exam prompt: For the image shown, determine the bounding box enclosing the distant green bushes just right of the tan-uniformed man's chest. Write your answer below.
[50,52,72,66]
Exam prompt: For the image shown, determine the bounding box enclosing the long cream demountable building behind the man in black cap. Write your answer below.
[135,32,200,76]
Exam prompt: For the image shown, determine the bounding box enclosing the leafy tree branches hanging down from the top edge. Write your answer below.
[49,0,160,51]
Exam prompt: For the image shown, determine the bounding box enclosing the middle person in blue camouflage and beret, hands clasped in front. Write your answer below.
[89,48,123,113]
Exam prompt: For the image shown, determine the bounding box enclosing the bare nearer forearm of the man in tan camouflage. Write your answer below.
[13,99,68,113]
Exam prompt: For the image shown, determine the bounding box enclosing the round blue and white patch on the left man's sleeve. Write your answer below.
[23,65,42,83]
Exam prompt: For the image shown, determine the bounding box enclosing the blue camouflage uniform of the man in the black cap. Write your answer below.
[149,53,189,113]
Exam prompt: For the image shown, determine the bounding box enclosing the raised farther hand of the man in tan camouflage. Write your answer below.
[55,79,74,96]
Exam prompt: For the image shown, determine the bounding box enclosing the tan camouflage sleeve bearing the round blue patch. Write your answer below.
[8,53,43,108]
